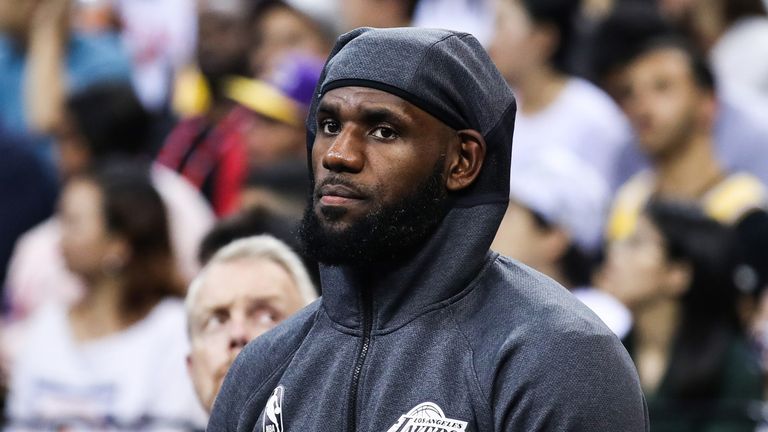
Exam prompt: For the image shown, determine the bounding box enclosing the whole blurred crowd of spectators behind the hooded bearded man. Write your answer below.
[0,0,768,432]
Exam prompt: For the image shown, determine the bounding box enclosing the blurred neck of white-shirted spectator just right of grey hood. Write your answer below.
[515,65,568,115]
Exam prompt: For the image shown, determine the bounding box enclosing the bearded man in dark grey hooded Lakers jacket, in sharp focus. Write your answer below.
[208,28,648,432]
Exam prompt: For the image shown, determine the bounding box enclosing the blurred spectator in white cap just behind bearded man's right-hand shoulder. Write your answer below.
[491,149,632,337]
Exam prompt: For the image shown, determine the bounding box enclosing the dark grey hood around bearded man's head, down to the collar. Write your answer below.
[307,28,516,331]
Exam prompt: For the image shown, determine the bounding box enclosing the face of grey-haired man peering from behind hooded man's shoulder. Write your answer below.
[188,258,304,412]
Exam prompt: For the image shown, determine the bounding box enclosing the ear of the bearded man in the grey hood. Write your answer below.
[446,129,486,192]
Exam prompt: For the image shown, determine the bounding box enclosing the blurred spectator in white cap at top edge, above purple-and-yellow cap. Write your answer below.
[249,0,338,78]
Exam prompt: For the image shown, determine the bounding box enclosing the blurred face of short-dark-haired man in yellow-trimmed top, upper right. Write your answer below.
[618,48,712,159]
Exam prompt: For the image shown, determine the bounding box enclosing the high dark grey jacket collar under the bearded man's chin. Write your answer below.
[320,200,507,333]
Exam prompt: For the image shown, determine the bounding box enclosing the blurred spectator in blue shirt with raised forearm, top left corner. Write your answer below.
[0,0,130,156]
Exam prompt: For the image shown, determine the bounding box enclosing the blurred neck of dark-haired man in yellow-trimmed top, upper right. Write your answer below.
[655,134,724,199]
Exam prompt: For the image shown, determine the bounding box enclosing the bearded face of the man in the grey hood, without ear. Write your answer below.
[302,87,457,264]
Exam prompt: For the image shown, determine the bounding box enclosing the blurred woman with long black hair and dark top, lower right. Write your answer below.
[605,201,763,432]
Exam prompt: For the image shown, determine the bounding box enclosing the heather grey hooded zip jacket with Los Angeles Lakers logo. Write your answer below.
[208,29,648,432]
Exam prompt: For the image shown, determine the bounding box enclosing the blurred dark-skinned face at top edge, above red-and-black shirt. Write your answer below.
[197,0,248,79]
